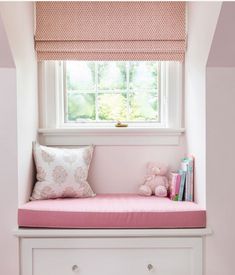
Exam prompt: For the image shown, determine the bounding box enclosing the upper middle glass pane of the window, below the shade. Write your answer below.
[98,61,126,90]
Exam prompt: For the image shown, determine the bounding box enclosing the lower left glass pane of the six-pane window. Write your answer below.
[67,93,95,122]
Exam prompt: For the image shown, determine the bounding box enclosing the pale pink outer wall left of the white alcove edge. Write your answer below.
[0,17,18,275]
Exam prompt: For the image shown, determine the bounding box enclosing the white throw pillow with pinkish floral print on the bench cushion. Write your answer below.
[30,143,95,200]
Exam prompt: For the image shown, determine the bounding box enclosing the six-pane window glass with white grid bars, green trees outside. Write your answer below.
[63,61,163,124]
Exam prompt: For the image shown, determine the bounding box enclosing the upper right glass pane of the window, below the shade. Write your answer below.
[129,61,158,89]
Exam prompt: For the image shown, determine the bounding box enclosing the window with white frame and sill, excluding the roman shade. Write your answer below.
[38,61,183,145]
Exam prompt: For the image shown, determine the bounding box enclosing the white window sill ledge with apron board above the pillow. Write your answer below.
[38,127,185,146]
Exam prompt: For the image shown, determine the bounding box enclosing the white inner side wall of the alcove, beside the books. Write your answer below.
[185,2,221,207]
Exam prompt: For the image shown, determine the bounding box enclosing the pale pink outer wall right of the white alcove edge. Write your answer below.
[206,2,235,275]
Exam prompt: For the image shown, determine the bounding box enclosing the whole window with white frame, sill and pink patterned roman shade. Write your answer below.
[35,1,186,145]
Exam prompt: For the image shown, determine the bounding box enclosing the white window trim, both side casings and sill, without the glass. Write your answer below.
[38,61,184,145]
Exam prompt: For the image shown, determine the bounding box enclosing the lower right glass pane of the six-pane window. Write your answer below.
[129,93,159,121]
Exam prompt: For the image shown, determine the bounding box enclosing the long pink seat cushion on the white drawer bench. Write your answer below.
[18,194,206,228]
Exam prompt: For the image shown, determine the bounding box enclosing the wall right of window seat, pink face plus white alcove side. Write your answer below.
[185,2,235,275]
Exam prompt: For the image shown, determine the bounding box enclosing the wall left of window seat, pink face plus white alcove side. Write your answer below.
[0,2,37,275]
